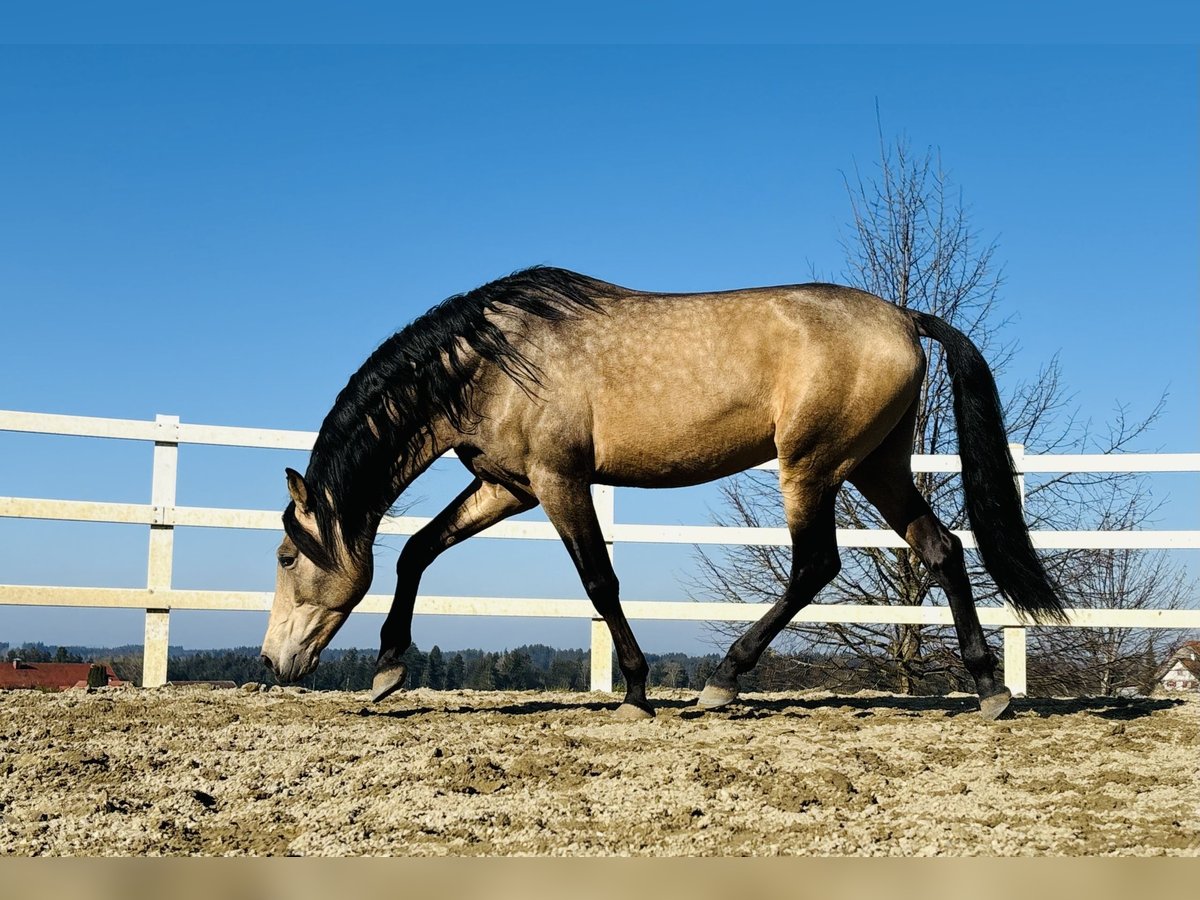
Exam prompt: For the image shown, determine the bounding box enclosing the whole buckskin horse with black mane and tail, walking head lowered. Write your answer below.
[263,266,1063,719]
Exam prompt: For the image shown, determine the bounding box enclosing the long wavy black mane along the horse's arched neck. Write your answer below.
[283,266,612,569]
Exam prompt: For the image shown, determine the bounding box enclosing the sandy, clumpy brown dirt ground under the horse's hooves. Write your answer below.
[0,686,1200,856]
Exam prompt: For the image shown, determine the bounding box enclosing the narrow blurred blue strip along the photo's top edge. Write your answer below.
[7,0,1198,46]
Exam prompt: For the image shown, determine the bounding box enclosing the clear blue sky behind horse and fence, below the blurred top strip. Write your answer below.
[0,32,1200,649]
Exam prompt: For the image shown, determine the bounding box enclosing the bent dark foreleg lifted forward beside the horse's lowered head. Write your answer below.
[371,478,538,701]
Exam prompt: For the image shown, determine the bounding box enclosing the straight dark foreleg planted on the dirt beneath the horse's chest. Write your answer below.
[535,479,654,719]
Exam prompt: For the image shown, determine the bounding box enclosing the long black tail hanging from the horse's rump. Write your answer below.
[907,310,1067,622]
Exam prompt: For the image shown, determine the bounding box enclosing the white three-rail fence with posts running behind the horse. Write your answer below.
[0,410,1200,694]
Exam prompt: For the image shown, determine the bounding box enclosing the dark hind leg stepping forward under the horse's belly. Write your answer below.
[697,466,841,709]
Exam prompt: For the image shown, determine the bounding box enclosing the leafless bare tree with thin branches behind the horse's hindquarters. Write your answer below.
[694,136,1182,692]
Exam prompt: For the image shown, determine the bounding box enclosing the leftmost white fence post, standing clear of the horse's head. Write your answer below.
[142,415,179,688]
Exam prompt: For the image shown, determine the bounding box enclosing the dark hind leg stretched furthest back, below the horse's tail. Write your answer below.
[850,428,1012,719]
